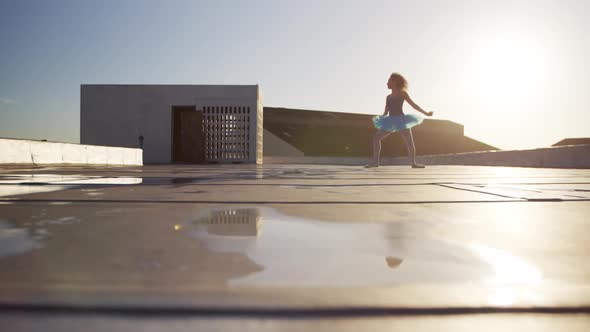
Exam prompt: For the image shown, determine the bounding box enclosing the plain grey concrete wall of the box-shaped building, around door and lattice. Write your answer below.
[80,84,262,164]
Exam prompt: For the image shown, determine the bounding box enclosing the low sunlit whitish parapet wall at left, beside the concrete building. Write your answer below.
[0,138,143,165]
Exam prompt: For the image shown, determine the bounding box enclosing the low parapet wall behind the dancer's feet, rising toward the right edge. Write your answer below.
[264,145,590,168]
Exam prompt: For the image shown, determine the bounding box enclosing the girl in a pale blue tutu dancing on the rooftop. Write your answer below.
[365,73,433,168]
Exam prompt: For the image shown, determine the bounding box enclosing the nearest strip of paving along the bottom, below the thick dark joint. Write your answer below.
[0,313,590,332]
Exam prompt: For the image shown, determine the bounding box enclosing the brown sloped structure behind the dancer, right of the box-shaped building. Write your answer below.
[264,107,498,157]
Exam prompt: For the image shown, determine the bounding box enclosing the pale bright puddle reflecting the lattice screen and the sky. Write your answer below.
[179,208,540,287]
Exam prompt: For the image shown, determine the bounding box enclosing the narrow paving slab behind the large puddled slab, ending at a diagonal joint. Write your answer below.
[3,184,520,204]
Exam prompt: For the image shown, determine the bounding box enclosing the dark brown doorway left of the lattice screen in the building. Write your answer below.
[172,106,205,163]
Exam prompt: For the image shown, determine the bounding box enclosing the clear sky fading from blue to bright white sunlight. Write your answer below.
[0,0,590,149]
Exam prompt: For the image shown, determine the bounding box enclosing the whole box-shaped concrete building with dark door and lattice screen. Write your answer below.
[80,84,263,164]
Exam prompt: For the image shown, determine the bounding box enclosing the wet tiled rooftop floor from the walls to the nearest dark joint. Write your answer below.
[0,165,590,328]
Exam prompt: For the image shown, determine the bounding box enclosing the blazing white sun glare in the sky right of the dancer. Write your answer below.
[457,27,558,148]
